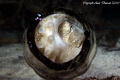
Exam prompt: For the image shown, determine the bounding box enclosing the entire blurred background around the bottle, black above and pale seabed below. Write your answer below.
[0,0,120,80]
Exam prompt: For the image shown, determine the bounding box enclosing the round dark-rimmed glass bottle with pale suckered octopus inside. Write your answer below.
[24,8,96,80]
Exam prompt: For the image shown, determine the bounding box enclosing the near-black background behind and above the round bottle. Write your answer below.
[0,0,120,47]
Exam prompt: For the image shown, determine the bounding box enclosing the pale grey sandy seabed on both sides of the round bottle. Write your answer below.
[0,44,120,80]
